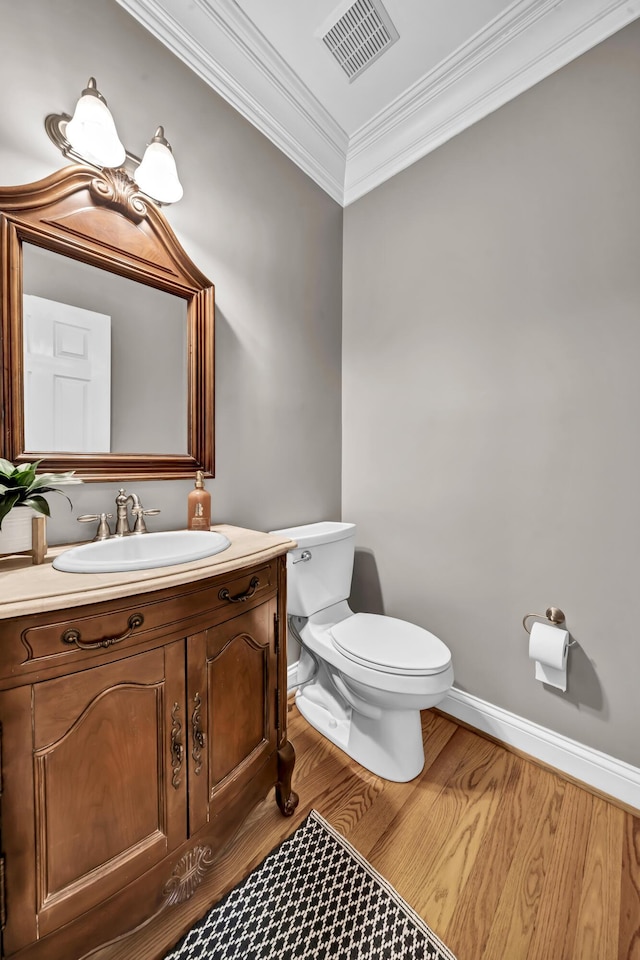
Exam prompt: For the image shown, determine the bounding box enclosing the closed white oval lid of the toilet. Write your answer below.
[331,613,451,676]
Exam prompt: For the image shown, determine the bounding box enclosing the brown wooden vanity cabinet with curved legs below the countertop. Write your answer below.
[0,557,297,960]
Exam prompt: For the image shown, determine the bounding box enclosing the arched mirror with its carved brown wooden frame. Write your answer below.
[0,166,214,481]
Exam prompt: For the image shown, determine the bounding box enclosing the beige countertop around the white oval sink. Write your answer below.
[0,523,295,620]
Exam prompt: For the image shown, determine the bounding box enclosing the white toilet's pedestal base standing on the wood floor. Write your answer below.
[296,683,424,783]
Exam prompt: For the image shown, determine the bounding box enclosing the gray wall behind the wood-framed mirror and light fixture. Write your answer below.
[0,0,342,543]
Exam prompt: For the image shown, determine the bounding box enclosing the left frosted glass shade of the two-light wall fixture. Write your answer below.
[65,77,126,167]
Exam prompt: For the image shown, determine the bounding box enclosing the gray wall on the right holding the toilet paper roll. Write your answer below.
[343,23,640,765]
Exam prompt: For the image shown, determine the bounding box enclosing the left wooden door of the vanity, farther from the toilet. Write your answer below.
[0,641,187,955]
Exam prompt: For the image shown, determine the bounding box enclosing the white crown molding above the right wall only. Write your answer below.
[343,0,640,206]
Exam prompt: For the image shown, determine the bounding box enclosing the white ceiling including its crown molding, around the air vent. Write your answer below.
[118,0,640,205]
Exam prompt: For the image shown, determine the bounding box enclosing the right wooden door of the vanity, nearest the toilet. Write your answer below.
[187,597,278,834]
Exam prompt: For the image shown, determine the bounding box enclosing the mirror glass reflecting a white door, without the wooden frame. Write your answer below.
[23,243,188,454]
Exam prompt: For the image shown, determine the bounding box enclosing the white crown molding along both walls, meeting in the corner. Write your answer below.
[118,0,640,206]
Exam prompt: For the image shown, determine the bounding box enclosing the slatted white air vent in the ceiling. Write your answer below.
[322,0,398,82]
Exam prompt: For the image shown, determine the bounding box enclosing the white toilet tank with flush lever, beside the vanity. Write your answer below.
[271,521,356,617]
